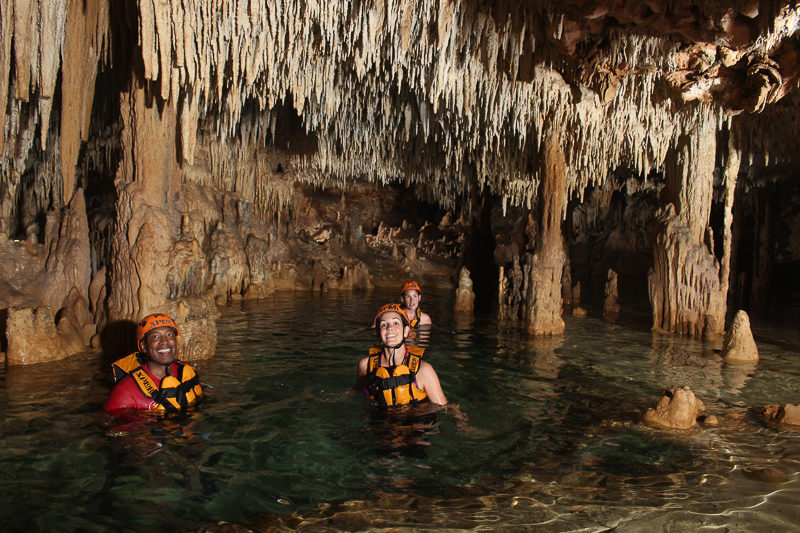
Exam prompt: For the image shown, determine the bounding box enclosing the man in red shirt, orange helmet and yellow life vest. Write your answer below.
[103,314,203,413]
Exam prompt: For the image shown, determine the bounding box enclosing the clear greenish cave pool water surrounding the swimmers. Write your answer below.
[0,291,800,532]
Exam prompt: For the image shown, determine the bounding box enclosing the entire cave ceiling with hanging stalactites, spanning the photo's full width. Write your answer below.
[0,0,800,216]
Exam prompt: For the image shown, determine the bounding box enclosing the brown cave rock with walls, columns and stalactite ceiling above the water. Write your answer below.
[0,0,800,362]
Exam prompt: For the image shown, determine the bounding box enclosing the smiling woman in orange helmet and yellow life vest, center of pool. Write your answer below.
[355,304,447,407]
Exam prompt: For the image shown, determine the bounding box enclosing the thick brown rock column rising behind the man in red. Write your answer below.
[108,81,216,360]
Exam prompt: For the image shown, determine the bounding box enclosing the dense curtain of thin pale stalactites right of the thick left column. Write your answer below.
[111,0,789,212]
